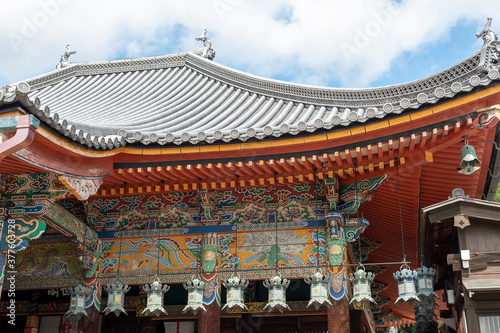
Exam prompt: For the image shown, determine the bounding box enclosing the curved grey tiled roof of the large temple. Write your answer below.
[0,36,499,149]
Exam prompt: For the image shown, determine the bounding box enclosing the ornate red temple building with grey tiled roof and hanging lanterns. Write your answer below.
[0,19,500,333]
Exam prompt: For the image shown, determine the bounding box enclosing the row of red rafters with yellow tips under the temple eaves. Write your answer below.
[88,116,498,195]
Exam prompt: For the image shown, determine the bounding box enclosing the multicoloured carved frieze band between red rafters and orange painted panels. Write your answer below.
[61,184,323,231]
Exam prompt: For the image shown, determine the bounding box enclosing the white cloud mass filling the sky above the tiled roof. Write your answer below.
[0,0,500,86]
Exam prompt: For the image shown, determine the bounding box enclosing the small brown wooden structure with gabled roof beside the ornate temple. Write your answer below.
[422,189,500,332]
